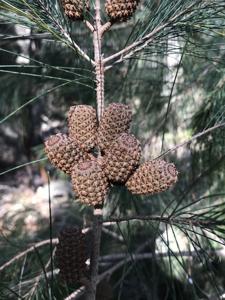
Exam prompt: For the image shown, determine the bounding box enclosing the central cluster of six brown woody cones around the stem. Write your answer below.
[45,103,177,207]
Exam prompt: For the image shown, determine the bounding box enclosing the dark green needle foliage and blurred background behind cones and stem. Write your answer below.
[0,0,225,300]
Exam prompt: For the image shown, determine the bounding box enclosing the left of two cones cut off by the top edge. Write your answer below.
[61,0,89,21]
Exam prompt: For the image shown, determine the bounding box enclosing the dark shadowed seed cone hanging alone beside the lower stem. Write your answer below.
[55,227,88,283]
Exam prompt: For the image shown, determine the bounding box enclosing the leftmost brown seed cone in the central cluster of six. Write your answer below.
[45,133,88,175]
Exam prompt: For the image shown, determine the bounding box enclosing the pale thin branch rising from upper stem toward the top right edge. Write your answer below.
[104,0,202,70]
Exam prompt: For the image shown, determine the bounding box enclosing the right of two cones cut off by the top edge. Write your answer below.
[105,0,139,22]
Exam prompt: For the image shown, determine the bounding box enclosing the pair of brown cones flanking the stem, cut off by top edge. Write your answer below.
[61,0,139,22]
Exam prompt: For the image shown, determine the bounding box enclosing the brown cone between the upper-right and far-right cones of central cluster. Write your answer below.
[104,133,141,183]
